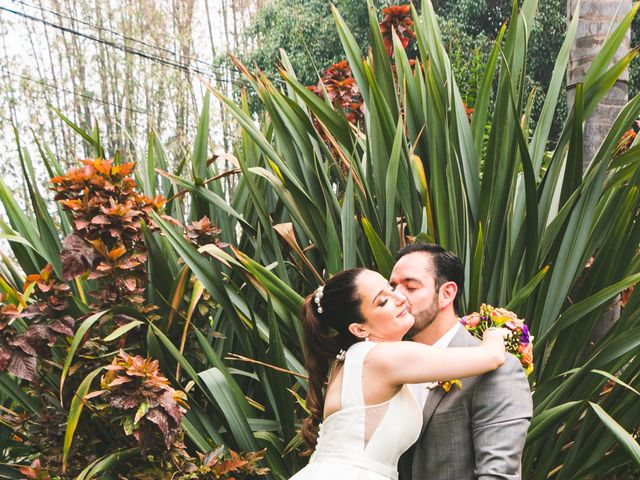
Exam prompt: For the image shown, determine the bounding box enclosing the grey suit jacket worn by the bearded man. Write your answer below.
[399,328,532,480]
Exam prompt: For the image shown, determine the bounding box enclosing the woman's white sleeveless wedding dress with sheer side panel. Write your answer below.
[291,342,422,480]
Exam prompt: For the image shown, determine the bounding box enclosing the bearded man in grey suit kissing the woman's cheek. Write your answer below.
[390,243,532,480]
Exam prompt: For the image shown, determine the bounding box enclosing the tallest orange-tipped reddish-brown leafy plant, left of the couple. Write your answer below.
[51,159,164,308]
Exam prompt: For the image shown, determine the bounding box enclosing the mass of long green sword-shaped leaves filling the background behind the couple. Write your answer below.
[0,0,640,479]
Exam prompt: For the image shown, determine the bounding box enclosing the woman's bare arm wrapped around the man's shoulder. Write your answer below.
[367,330,505,385]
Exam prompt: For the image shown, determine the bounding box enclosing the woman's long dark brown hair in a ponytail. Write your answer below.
[300,268,365,448]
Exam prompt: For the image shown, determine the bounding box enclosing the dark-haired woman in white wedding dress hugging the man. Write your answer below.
[291,269,505,480]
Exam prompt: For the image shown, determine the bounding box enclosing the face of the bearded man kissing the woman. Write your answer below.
[389,252,440,337]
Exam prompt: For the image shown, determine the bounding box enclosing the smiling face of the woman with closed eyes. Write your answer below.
[352,270,414,342]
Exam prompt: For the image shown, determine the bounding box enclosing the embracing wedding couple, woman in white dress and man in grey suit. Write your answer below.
[292,243,532,480]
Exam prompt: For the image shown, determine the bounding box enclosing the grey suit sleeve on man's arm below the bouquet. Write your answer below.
[471,355,533,480]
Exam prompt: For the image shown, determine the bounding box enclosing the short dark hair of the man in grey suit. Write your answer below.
[396,242,464,313]
